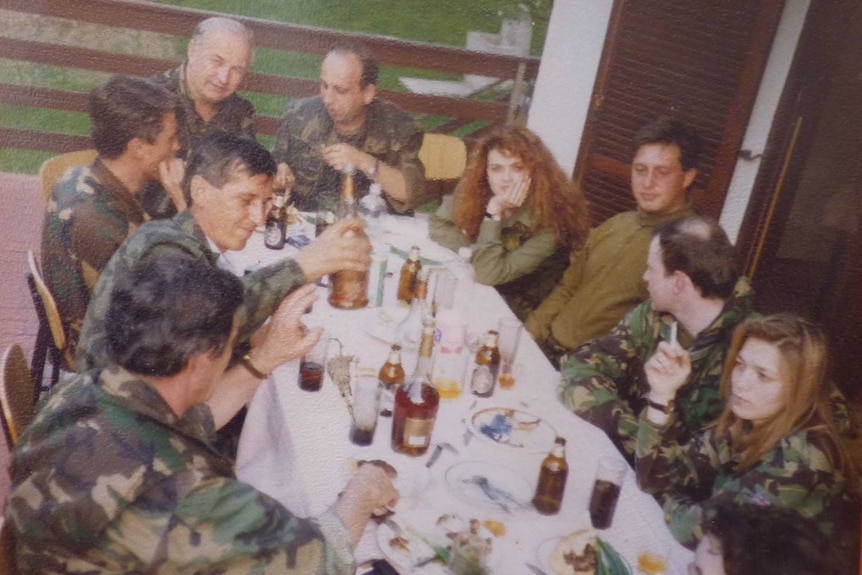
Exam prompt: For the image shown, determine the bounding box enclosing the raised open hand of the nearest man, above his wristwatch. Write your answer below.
[249,284,323,373]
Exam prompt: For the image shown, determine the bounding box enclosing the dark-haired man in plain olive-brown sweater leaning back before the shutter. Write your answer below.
[525,118,700,363]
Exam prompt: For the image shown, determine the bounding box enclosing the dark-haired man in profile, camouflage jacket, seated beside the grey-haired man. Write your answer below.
[41,76,177,359]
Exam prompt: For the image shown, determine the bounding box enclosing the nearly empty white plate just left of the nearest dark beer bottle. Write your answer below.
[446,461,533,512]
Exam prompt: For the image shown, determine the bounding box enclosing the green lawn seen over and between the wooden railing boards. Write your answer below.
[0,0,550,174]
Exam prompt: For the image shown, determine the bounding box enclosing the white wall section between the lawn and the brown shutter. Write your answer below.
[527,0,613,174]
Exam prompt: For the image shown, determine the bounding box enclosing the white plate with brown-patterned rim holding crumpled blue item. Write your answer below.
[467,407,557,453]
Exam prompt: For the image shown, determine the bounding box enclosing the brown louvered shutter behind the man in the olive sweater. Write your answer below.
[574,0,784,224]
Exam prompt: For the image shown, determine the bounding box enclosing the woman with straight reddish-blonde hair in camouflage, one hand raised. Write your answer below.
[636,314,859,555]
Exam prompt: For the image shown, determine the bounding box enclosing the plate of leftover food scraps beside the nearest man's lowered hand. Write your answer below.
[377,510,506,575]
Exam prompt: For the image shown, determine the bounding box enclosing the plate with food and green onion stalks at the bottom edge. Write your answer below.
[536,527,631,575]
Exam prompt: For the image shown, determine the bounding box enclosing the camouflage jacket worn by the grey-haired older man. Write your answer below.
[152,63,254,158]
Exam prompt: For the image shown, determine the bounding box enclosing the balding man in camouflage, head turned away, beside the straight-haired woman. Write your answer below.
[558,216,754,461]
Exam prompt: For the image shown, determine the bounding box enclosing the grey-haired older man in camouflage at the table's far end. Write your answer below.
[145,16,254,216]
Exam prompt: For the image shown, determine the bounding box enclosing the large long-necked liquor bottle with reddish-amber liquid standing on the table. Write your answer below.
[392,317,440,456]
